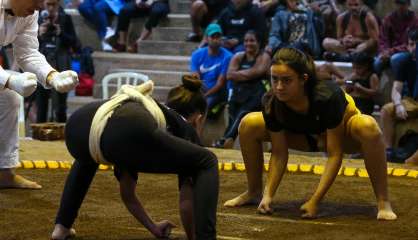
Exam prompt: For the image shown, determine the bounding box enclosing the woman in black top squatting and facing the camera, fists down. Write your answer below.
[225,48,397,220]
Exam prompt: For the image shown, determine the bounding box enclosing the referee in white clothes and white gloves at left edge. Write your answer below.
[0,0,78,189]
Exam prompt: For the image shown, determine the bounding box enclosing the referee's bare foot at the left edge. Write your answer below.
[0,170,42,189]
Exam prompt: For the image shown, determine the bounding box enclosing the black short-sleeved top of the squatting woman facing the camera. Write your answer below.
[263,81,348,134]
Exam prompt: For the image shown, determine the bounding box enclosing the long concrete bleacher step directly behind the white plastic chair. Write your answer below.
[93,52,190,83]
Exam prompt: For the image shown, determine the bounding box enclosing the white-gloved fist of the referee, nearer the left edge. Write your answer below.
[8,72,37,97]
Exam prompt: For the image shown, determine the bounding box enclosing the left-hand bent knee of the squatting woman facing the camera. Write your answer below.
[238,112,265,138]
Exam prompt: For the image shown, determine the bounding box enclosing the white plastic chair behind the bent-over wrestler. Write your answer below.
[102,72,149,99]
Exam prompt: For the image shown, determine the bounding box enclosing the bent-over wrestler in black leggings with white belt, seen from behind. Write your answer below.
[52,77,219,240]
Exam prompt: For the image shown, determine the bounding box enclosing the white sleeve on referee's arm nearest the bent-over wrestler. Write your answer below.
[13,12,55,88]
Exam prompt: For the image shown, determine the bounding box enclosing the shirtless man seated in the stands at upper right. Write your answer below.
[323,0,379,62]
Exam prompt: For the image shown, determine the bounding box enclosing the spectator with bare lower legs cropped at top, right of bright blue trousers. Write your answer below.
[112,0,170,53]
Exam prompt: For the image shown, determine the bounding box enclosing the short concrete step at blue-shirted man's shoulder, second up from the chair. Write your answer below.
[138,40,198,56]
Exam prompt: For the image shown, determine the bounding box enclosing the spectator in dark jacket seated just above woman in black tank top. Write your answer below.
[218,0,268,53]
